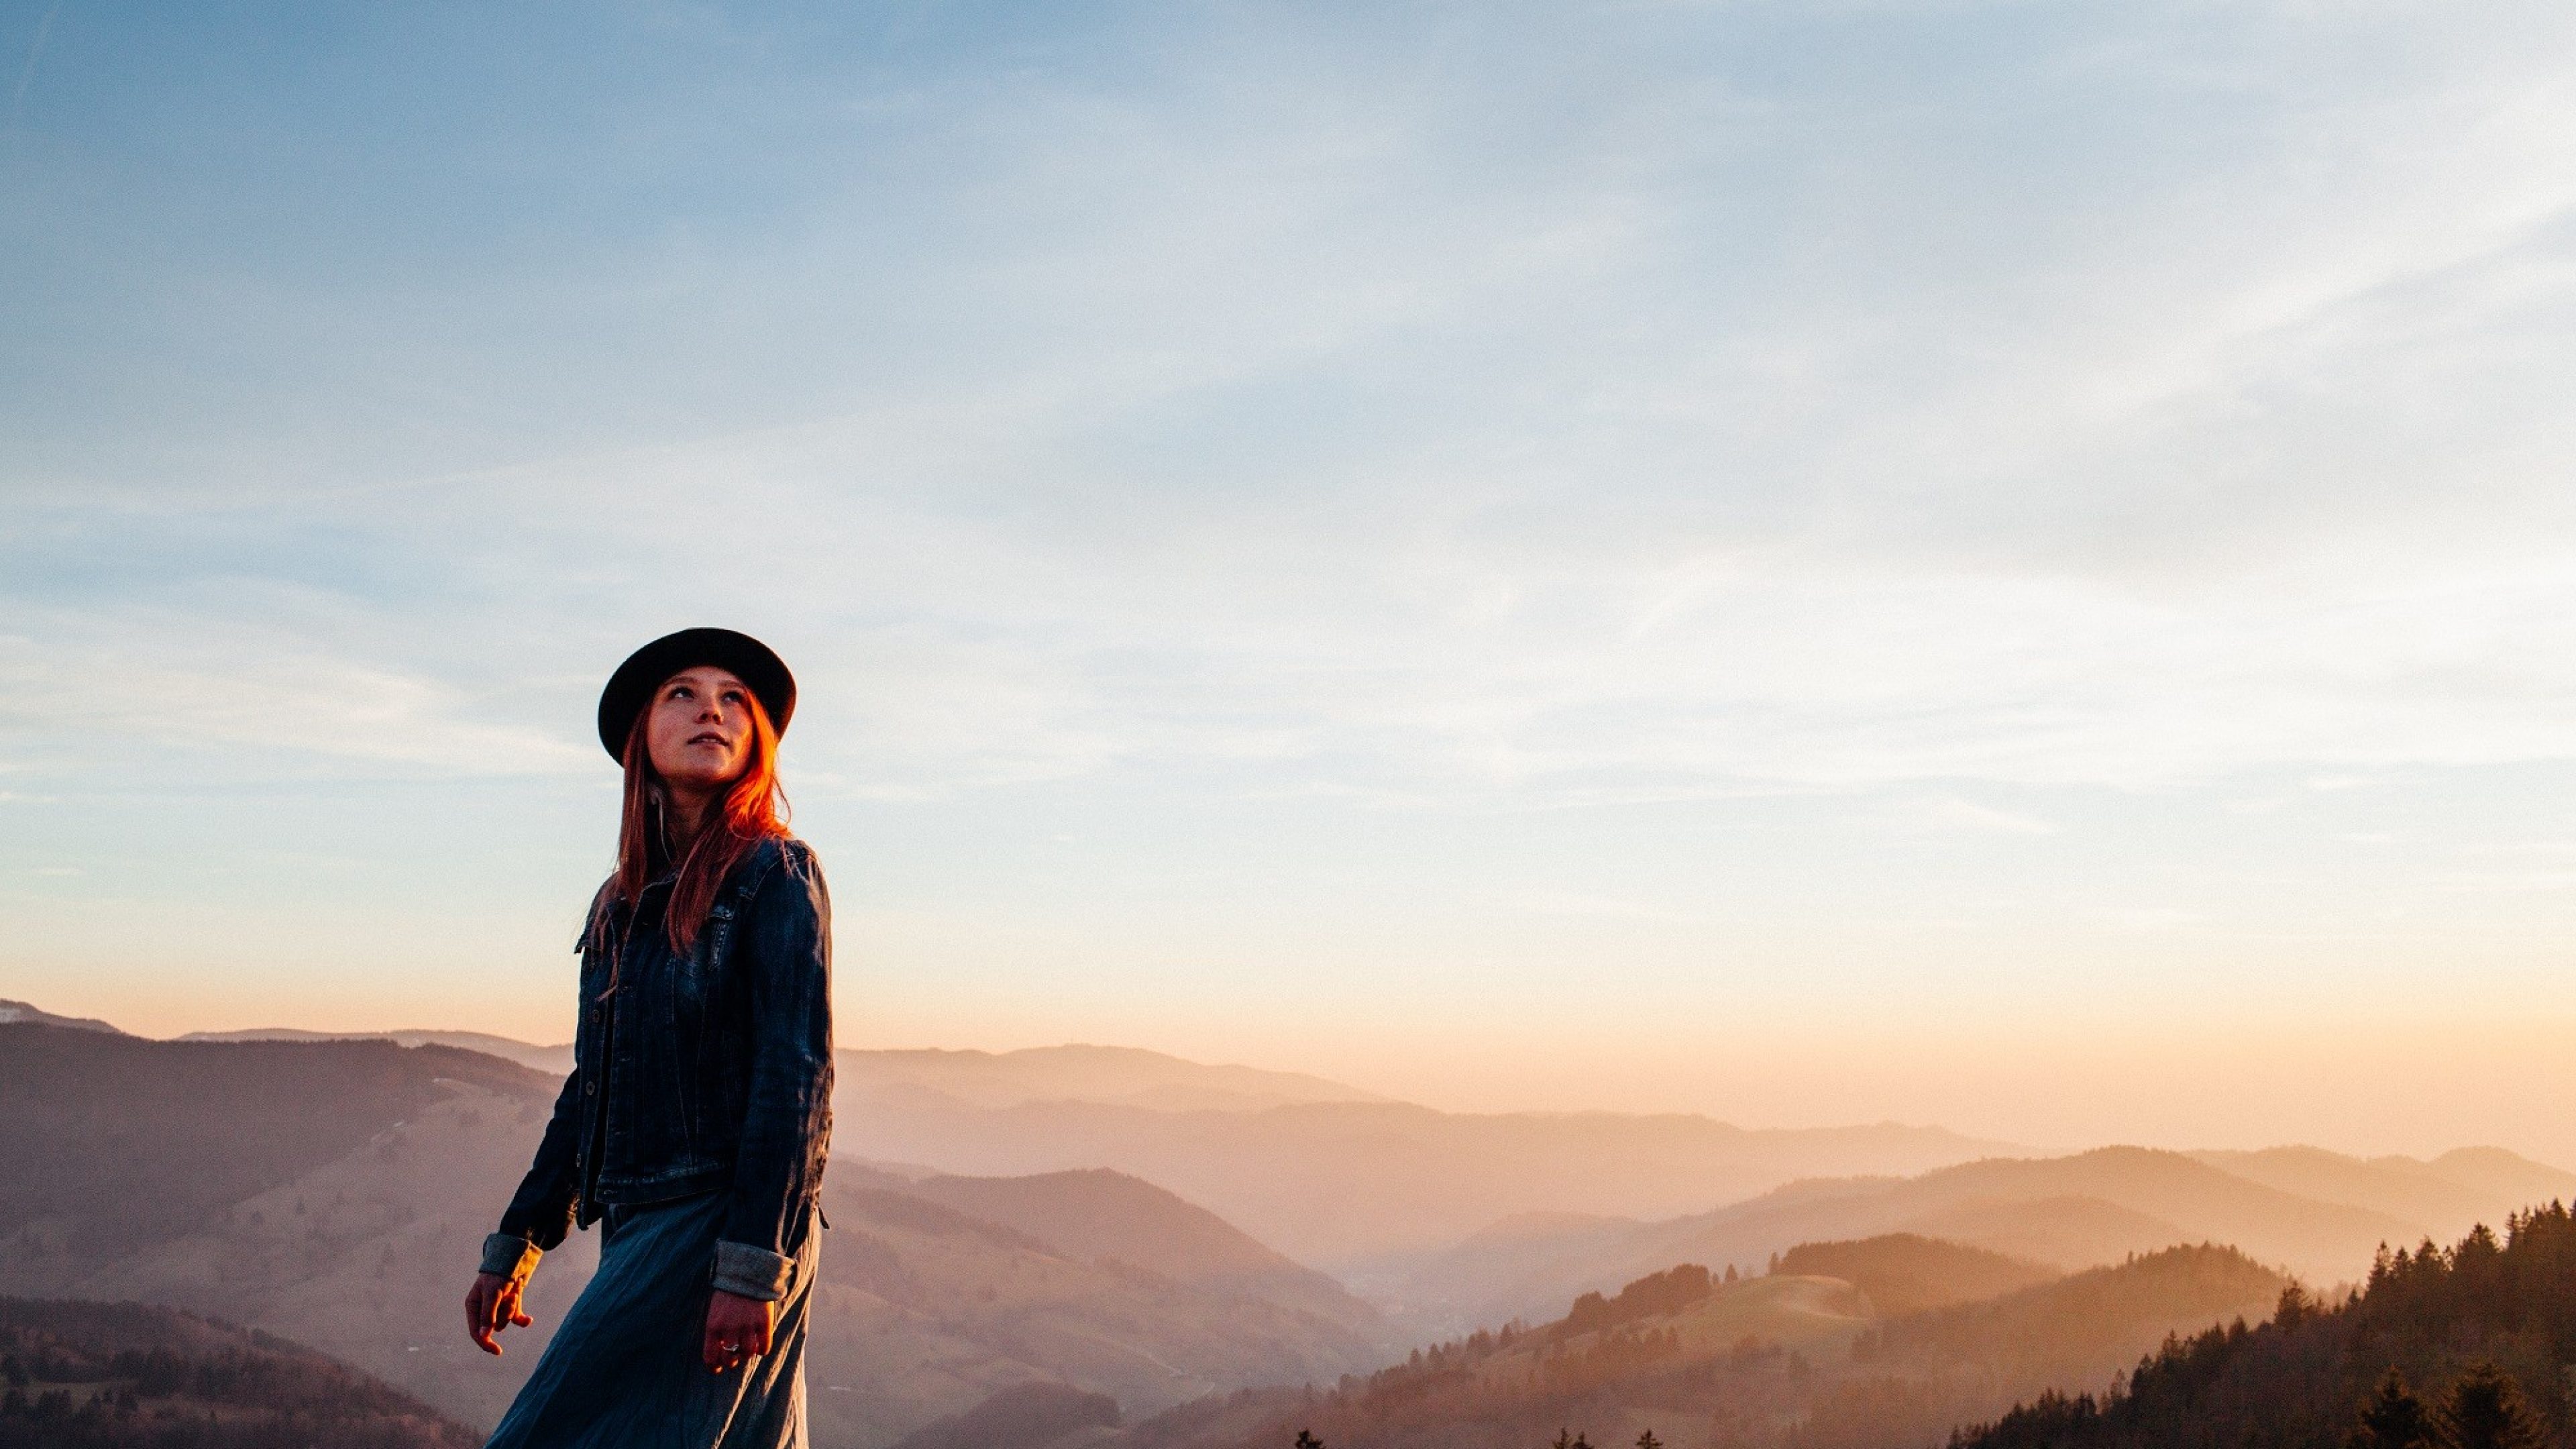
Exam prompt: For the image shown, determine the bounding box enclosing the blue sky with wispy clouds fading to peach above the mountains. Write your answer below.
[0,0,2576,1150]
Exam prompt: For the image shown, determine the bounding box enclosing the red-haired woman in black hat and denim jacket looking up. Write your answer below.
[466,629,832,1449]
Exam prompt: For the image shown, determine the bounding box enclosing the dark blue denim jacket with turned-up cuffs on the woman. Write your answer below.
[484,841,832,1299]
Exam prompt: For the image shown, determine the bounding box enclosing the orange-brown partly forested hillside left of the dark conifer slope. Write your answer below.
[1120,1238,2285,1449]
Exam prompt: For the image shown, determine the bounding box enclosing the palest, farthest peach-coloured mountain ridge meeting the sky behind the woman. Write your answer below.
[161,1029,2012,1273]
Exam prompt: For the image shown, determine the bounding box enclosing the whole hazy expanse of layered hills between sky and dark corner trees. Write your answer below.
[0,1003,2576,1449]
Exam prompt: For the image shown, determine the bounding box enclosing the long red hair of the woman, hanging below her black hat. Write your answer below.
[600,691,788,954]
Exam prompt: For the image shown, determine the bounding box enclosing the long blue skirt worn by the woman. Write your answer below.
[487,1191,822,1449]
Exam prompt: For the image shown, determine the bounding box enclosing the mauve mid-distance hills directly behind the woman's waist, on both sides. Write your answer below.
[0,1024,1393,1446]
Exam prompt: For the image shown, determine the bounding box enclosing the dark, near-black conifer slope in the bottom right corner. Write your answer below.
[1950,1204,2576,1449]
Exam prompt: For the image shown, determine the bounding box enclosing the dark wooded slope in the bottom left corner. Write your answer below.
[0,1299,476,1449]
